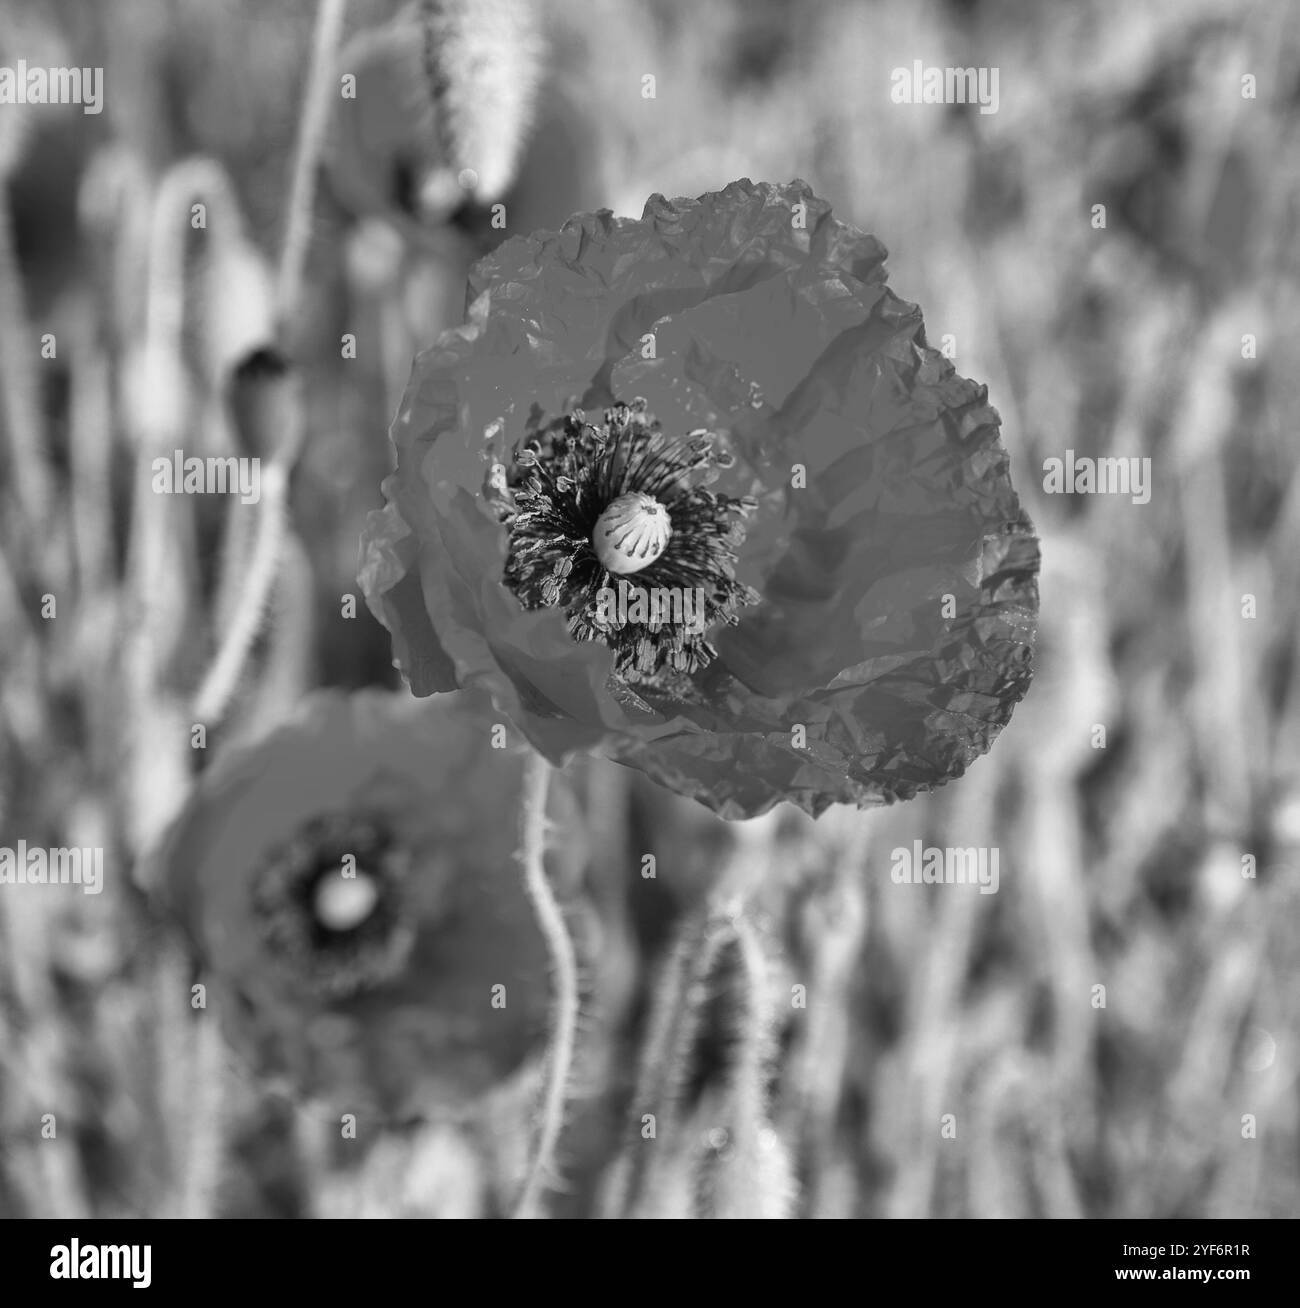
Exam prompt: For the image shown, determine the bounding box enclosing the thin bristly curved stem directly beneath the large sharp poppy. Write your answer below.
[514,752,578,1218]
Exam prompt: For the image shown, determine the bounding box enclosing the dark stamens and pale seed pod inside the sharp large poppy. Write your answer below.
[496,399,759,684]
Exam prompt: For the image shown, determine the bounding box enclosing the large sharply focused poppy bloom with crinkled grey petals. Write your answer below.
[361,181,1038,818]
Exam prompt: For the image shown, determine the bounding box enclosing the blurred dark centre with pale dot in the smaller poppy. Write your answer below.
[252,818,415,999]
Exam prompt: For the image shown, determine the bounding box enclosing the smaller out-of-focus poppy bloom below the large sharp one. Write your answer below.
[158,692,578,1121]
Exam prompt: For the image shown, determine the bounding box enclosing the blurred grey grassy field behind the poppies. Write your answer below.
[0,0,1300,1216]
